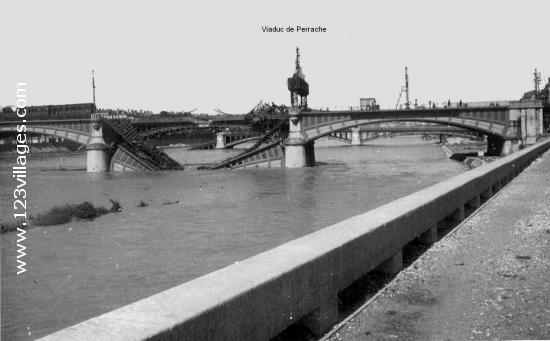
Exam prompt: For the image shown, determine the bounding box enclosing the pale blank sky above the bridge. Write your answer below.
[0,0,550,113]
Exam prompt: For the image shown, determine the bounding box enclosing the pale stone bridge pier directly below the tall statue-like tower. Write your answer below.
[285,107,315,168]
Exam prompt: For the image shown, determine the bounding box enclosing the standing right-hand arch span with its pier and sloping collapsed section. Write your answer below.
[211,100,543,168]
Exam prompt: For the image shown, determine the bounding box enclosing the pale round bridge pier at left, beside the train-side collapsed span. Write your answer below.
[86,114,110,173]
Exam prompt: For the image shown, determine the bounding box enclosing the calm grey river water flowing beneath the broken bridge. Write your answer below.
[0,137,467,340]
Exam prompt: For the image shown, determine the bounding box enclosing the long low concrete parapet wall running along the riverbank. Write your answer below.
[38,141,550,341]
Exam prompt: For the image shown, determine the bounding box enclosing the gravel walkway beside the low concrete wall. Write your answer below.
[324,153,550,341]
